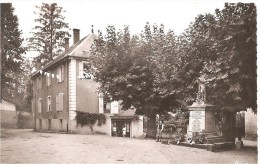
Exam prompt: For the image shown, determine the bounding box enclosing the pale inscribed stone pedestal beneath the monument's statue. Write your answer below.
[187,102,217,136]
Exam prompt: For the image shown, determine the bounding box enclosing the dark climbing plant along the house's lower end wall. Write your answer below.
[76,111,106,127]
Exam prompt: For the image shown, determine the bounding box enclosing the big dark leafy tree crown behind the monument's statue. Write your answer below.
[174,3,256,111]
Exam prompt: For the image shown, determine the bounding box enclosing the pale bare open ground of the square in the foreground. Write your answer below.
[1,130,257,164]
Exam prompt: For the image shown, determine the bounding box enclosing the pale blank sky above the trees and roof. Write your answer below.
[4,0,260,56]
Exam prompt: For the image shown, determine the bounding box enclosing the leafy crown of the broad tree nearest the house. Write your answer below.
[92,23,181,115]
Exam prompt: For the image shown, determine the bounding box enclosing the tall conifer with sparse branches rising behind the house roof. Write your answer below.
[29,3,70,65]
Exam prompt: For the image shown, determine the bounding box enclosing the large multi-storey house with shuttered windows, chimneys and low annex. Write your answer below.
[32,29,143,137]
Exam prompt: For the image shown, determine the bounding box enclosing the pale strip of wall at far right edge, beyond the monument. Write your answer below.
[245,109,257,140]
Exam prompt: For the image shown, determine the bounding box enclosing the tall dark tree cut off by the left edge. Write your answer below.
[0,3,26,101]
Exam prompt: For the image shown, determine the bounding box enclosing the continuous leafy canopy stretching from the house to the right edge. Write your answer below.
[92,3,256,114]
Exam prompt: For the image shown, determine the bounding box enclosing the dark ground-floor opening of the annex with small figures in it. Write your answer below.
[111,120,131,137]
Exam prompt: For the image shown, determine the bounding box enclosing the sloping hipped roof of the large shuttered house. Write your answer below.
[32,33,97,77]
